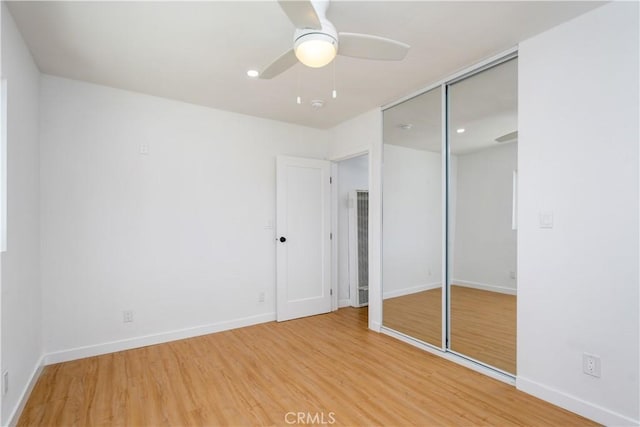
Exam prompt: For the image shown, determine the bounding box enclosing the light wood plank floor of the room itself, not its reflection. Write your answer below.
[18,308,594,426]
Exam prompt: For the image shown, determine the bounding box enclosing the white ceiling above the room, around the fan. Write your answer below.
[8,0,602,128]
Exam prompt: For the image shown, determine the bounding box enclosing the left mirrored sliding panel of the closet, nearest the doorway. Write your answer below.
[382,87,443,347]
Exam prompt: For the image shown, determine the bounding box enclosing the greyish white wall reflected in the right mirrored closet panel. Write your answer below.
[452,143,518,293]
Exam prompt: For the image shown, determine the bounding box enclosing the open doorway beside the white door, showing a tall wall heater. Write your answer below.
[337,154,369,311]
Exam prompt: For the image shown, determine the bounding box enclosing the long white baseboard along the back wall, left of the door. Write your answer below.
[44,313,276,365]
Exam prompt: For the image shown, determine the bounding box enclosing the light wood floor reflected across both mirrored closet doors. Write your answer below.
[382,285,516,374]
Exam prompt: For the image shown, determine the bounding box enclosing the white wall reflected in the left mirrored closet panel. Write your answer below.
[382,144,442,299]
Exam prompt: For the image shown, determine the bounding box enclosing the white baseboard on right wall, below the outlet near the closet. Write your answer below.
[516,377,640,426]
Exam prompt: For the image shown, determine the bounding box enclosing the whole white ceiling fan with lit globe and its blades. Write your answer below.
[260,0,410,79]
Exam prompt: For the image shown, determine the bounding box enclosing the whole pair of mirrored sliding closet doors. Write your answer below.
[382,54,518,375]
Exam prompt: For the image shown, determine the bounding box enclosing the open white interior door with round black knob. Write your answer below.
[276,156,331,321]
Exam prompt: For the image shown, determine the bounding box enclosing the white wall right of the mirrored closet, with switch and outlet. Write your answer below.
[517,2,640,425]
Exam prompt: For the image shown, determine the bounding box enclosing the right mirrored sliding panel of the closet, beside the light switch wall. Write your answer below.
[447,59,518,374]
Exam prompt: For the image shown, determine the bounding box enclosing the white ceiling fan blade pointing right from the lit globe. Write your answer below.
[338,33,411,61]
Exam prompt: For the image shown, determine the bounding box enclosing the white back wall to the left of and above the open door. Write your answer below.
[40,75,328,362]
